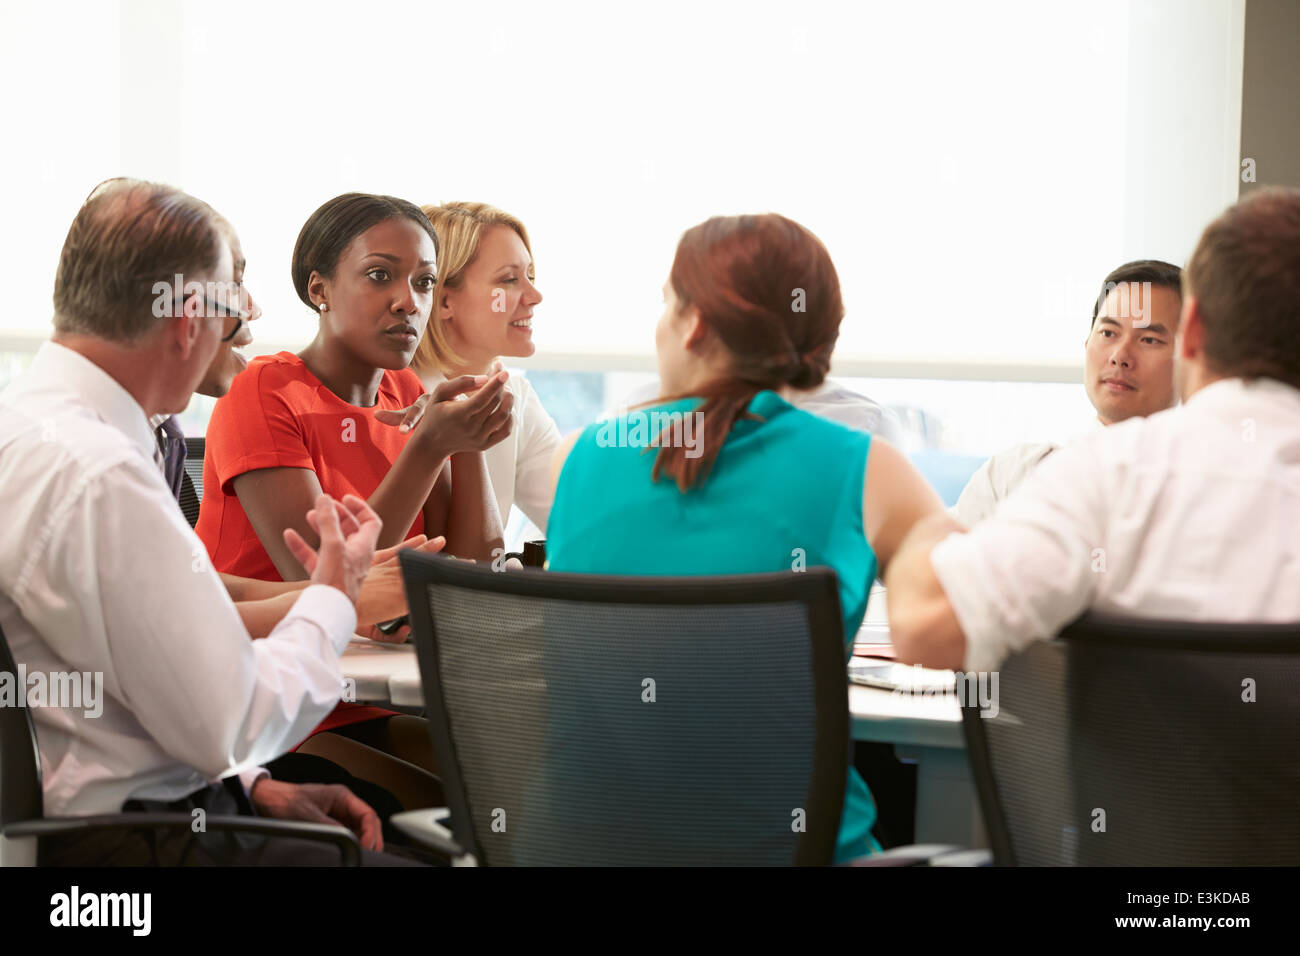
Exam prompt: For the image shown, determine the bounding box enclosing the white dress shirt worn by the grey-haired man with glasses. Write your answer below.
[0,342,356,816]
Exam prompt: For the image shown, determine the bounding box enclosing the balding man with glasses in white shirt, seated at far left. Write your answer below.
[0,181,405,864]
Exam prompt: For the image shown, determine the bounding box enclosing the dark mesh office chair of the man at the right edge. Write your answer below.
[962,614,1300,866]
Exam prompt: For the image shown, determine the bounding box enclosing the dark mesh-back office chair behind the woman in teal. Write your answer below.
[400,551,850,865]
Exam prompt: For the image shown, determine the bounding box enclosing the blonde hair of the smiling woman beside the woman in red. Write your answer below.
[411,203,534,376]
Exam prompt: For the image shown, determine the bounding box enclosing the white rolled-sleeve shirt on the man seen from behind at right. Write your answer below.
[930,378,1300,671]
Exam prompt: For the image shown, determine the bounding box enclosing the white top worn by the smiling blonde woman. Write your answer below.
[420,372,560,535]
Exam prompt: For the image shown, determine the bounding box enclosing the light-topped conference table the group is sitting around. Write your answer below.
[341,615,988,848]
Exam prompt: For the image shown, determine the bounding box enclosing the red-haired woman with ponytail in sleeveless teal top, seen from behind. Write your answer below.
[546,215,943,862]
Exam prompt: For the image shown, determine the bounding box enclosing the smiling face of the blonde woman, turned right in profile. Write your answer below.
[441,225,542,369]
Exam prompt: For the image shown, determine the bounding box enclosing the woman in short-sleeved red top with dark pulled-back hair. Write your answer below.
[195,193,512,803]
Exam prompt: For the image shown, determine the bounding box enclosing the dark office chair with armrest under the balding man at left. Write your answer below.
[0,621,361,866]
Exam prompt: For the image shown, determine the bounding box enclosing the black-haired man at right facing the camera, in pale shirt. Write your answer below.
[950,259,1183,525]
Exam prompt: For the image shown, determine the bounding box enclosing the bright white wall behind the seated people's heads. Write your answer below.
[0,0,1243,380]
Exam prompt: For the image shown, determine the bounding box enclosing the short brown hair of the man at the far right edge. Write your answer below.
[1186,187,1300,389]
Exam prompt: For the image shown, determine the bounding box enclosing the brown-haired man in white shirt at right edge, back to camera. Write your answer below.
[885,190,1300,671]
